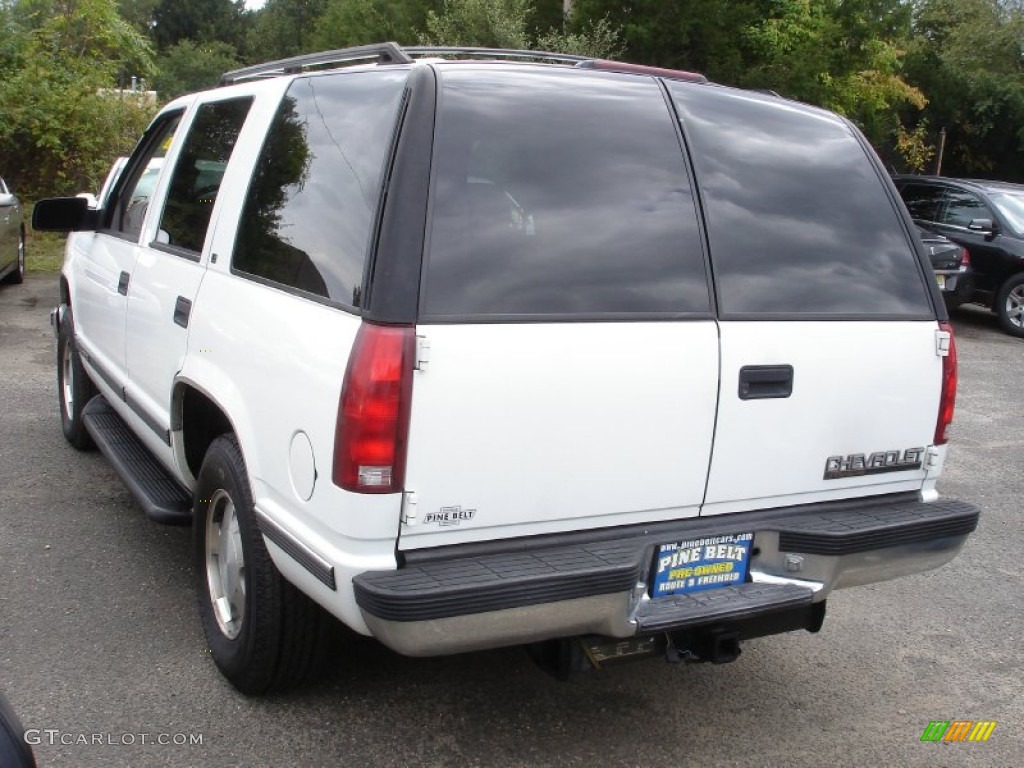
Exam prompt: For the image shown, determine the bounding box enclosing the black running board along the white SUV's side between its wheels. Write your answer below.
[82,394,193,525]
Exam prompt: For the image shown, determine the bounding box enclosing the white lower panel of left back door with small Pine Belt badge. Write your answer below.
[399,321,718,550]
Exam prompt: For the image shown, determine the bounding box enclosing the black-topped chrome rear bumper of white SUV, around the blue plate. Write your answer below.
[354,495,979,656]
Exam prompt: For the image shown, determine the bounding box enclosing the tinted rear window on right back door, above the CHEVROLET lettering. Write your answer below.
[669,83,933,319]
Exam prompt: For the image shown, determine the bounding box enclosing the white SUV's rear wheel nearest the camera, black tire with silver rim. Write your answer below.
[193,434,328,694]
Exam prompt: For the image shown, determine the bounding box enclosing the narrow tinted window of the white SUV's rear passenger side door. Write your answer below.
[157,98,252,253]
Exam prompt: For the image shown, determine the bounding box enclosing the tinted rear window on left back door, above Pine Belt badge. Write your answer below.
[421,66,710,318]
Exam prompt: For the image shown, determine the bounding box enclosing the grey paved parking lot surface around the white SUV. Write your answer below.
[0,275,1024,768]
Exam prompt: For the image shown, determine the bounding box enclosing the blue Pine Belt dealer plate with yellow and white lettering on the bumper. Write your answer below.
[650,534,754,597]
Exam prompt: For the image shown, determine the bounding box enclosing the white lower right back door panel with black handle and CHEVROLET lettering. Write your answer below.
[702,321,942,514]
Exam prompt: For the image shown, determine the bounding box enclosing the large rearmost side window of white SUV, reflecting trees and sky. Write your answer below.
[232,70,408,306]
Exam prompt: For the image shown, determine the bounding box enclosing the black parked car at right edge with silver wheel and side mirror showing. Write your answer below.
[894,176,1024,337]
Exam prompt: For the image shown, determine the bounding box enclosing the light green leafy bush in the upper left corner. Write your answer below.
[0,0,154,197]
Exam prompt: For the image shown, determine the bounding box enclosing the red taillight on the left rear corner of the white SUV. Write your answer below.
[334,323,416,494]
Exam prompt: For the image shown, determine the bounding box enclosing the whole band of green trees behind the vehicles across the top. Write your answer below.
[0,0,1024,194]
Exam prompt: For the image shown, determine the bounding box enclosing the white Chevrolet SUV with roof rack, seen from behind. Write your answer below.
[34,44,978,692]
